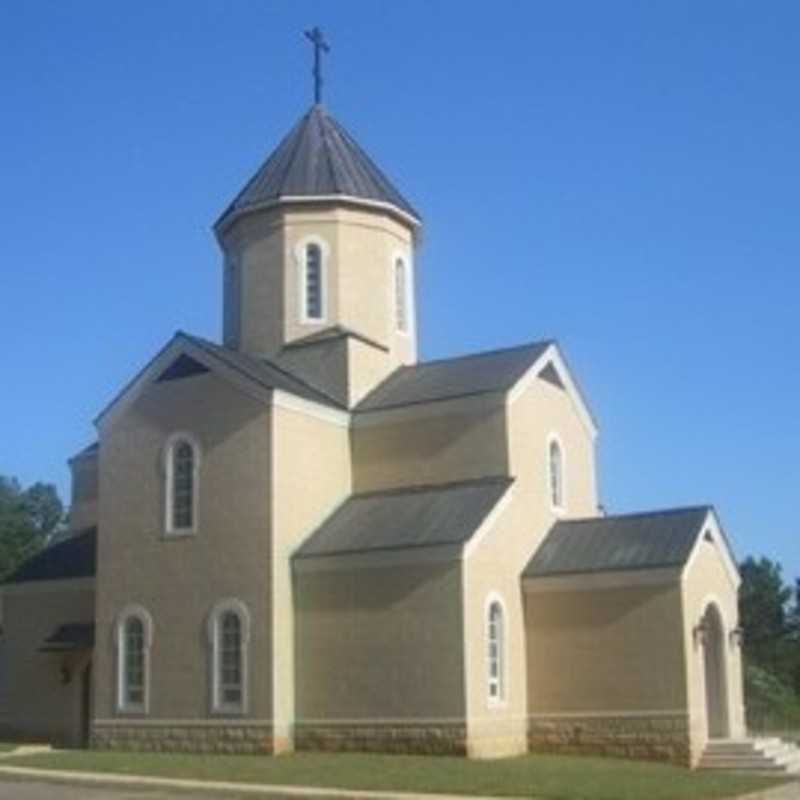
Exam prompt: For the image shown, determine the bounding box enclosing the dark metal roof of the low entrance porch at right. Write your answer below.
[523,506,712,578]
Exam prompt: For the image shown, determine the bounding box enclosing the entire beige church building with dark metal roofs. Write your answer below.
[0,78,745,766]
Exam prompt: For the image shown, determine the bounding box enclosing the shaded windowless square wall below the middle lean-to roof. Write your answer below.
[295,556,465,726]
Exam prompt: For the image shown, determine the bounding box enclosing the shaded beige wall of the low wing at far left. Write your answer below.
[0,579,95,747]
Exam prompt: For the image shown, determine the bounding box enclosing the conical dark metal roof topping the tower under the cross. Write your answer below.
[216,105,420,227]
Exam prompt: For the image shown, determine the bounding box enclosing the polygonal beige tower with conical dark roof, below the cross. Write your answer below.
[214,97,421,406]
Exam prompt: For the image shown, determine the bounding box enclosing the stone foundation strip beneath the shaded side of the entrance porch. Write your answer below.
[528,714,691,767]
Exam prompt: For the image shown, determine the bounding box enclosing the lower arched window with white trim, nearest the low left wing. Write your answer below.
[117,606,152,714]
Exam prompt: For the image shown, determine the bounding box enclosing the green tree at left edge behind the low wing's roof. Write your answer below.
[0,475,64,581]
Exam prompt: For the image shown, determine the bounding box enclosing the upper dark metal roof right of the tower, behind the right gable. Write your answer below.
[356,341,552,411]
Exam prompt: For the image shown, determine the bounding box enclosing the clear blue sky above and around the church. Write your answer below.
[0,0,800,576]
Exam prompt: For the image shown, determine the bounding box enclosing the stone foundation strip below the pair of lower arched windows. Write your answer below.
[91,722,276,755]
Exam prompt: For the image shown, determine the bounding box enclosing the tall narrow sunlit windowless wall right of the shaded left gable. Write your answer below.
[272,407,351,749]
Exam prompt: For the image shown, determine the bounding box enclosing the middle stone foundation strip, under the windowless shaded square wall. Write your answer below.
[294,722,467,756]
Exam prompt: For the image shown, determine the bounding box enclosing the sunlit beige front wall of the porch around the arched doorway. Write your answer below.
[683,518,745,760]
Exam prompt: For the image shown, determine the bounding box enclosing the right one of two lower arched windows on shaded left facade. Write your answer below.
[208,599,250,714]
